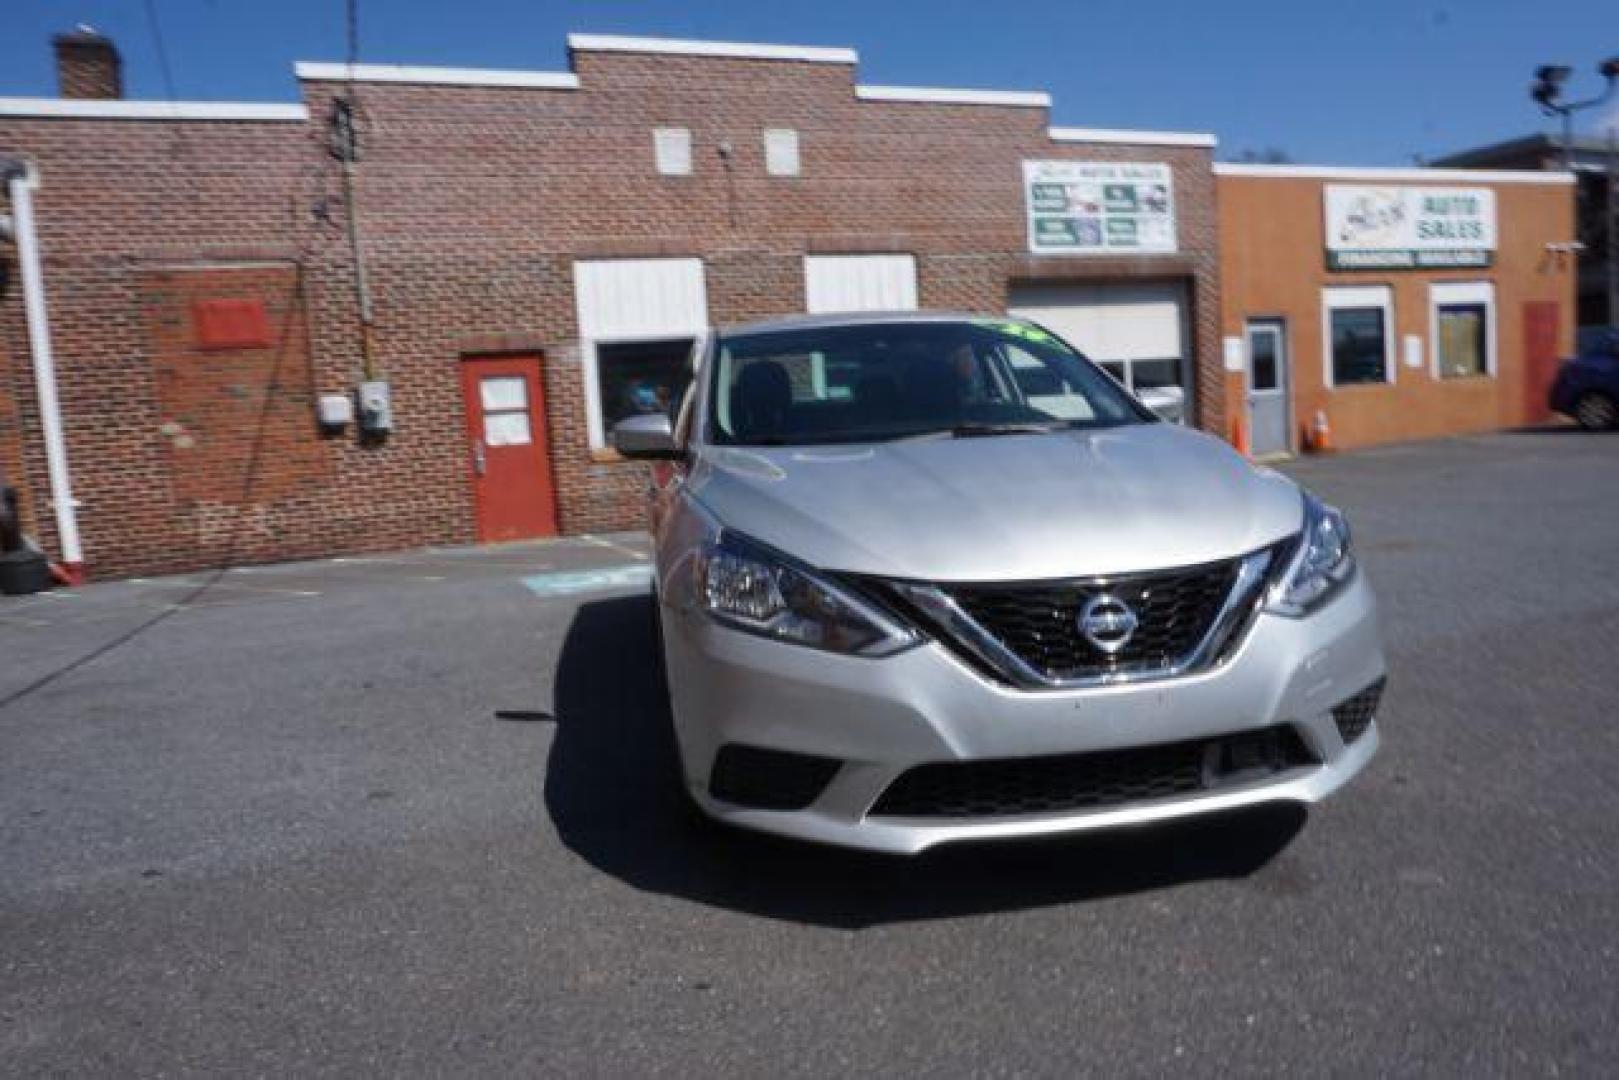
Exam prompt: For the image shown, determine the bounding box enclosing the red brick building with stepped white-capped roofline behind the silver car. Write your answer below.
[0,32,1567,575]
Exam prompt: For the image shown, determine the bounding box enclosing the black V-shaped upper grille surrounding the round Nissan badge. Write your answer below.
[941,559,1242,682]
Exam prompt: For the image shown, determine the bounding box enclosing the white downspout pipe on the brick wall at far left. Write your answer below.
[5,162,84,581]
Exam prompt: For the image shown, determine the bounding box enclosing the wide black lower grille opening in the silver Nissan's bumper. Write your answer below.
[871,725,1319,818]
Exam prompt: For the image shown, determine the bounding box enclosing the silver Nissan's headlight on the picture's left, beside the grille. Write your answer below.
[696,529,920,656]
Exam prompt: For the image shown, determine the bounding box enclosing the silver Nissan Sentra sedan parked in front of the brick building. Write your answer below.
[614,313,1384,852]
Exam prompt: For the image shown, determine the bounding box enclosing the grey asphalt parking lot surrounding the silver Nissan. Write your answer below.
[0,431,1619,1075]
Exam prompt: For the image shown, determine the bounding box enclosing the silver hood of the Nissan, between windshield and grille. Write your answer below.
[688,424,1303,581]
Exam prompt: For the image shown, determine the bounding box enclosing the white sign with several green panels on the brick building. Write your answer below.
[1023,162,1175,254]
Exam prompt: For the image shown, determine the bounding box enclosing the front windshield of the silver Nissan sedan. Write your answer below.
[709,319,1154,445]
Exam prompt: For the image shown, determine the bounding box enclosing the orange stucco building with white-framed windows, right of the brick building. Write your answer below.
[1216,165,1575,457]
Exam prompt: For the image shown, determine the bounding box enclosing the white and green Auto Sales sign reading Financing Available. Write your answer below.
[1326,185,1496,270]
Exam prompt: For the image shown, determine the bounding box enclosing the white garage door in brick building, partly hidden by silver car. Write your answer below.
[1010,282,1192,402]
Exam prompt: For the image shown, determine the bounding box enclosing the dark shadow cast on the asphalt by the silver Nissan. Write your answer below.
[546,596,1305,929]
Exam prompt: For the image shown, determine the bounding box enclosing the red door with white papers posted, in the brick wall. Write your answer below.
[461,356,557,542]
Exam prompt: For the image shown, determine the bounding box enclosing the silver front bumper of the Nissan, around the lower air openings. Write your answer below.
[662,575,1384,853]
